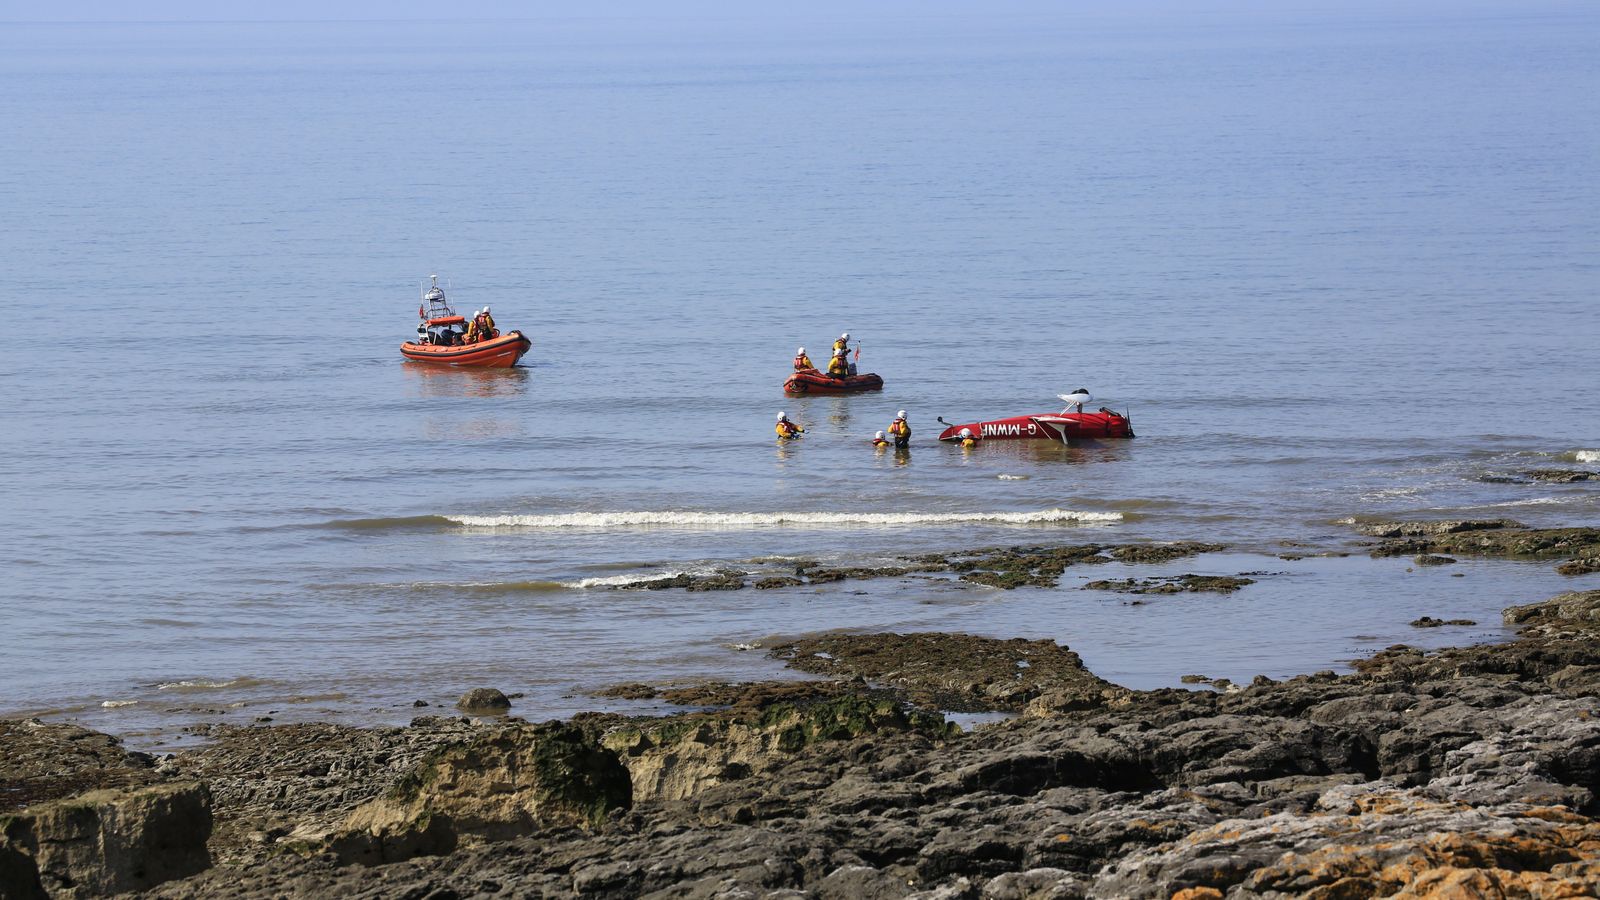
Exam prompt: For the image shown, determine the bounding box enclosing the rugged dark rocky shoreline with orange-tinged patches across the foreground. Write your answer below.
[0,522,1600,900]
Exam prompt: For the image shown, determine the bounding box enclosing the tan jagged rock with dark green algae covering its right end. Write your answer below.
[328,722,632,863]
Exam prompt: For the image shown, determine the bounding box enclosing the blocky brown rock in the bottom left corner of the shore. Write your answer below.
[0,781,211,898]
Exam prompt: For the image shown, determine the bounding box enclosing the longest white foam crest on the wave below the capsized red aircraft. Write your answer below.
[446,509,1122,528]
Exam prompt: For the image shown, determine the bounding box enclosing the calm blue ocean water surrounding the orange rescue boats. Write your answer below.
[0,3,1600,743]
